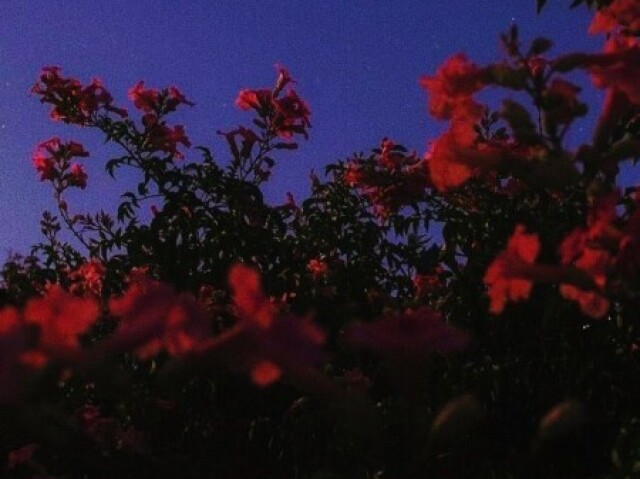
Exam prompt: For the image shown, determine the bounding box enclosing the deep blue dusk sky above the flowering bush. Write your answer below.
[0,0,602,256]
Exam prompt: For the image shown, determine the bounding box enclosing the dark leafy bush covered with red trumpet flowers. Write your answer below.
[0,0,640,479]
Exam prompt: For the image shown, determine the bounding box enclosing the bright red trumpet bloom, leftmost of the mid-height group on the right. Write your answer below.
[484,225,540,314]
